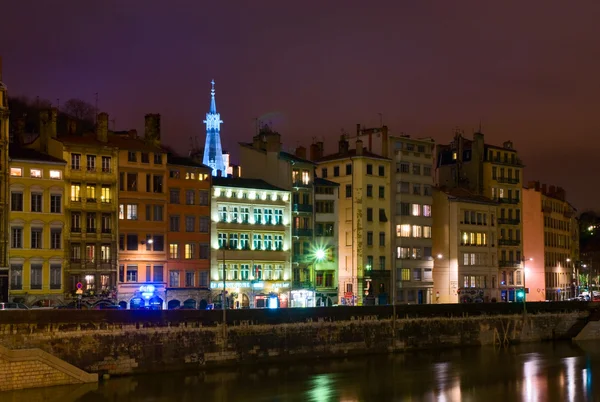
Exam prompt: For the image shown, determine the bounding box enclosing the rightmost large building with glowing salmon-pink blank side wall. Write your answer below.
[523,182,579,301]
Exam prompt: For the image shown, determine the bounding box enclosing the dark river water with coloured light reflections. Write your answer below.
[0,342,600,402]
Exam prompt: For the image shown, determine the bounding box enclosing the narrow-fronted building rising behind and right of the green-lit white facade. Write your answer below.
[240,126,317,307]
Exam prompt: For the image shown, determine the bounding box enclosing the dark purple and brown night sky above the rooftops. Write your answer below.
[0,0,600,210]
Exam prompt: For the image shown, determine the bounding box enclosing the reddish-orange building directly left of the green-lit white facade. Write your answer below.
[165,154,211,309]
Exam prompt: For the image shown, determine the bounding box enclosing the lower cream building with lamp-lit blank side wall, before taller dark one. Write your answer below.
[434,188,500,303]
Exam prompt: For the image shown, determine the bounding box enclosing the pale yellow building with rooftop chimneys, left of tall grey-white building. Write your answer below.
[316,136,394,305]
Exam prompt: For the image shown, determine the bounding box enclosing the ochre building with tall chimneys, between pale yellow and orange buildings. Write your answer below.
[27,109,118,303]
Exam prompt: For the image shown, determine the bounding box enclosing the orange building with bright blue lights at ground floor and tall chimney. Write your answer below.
[115,114,167,309]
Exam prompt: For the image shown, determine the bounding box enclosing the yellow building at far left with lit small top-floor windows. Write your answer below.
[9,144,68,306]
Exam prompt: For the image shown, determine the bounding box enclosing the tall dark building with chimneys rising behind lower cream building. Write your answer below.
[437,133,526,301]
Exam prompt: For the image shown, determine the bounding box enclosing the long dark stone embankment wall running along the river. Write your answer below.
[0,302,595,385]
